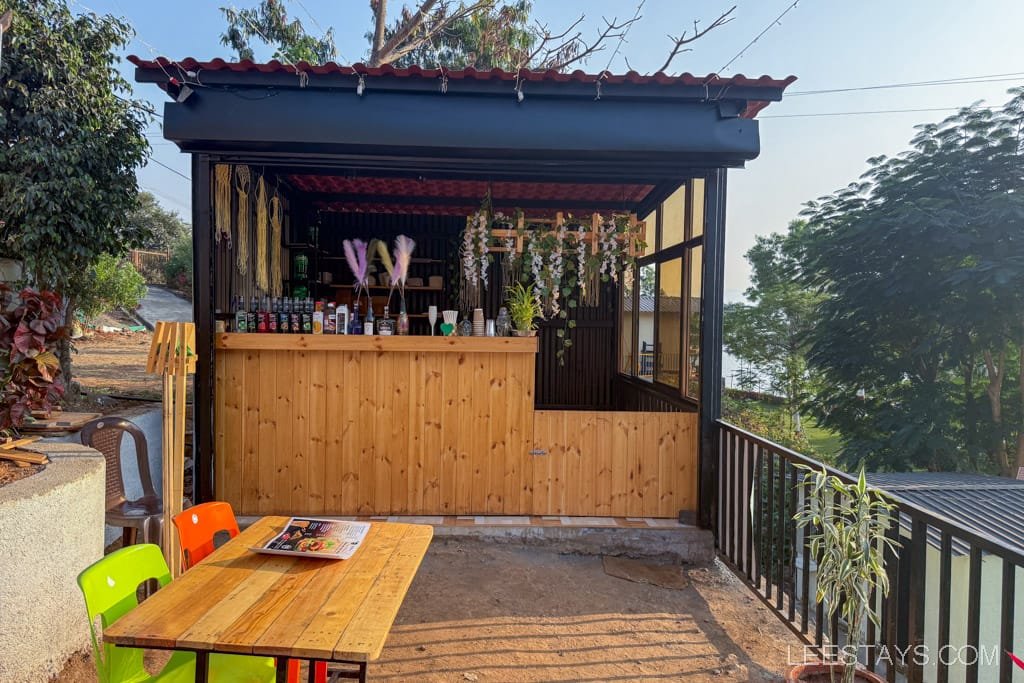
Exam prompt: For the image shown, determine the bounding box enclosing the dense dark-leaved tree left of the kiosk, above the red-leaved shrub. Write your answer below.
[0,0,148,382]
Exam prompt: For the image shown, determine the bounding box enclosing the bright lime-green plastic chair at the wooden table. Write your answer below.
[78,544,274,683]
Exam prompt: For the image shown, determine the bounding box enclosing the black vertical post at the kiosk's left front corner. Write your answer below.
[191,155,214,503]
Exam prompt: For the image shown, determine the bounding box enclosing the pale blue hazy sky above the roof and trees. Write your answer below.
[69,0,1024,301]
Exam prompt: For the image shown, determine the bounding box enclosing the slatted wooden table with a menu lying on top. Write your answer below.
[103,517,433,682]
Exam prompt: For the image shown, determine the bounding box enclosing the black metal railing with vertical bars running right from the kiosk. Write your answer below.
[714,421,1024,683]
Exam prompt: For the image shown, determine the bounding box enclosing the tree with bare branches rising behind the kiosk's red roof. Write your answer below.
[220,0,735,71]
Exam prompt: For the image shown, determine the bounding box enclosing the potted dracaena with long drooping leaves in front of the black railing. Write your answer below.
[785,466,899,683]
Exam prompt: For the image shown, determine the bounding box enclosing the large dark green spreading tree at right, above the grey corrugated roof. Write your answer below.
[804,88,1024,474]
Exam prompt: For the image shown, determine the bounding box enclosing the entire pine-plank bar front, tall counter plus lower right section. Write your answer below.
[214,334,696,517]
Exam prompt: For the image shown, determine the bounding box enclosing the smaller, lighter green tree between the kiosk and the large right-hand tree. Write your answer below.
[724,220,821,433]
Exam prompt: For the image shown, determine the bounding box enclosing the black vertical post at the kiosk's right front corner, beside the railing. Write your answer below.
[697,168,726,532]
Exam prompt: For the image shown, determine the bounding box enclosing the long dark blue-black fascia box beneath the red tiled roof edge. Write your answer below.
[157,88,760,176]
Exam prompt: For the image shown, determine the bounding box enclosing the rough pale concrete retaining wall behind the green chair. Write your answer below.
[0,443,104,683]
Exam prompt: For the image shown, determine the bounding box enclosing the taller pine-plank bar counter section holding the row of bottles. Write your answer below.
[214,334,538,515]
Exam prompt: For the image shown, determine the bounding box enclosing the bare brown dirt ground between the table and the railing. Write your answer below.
[56,541,801,683]
